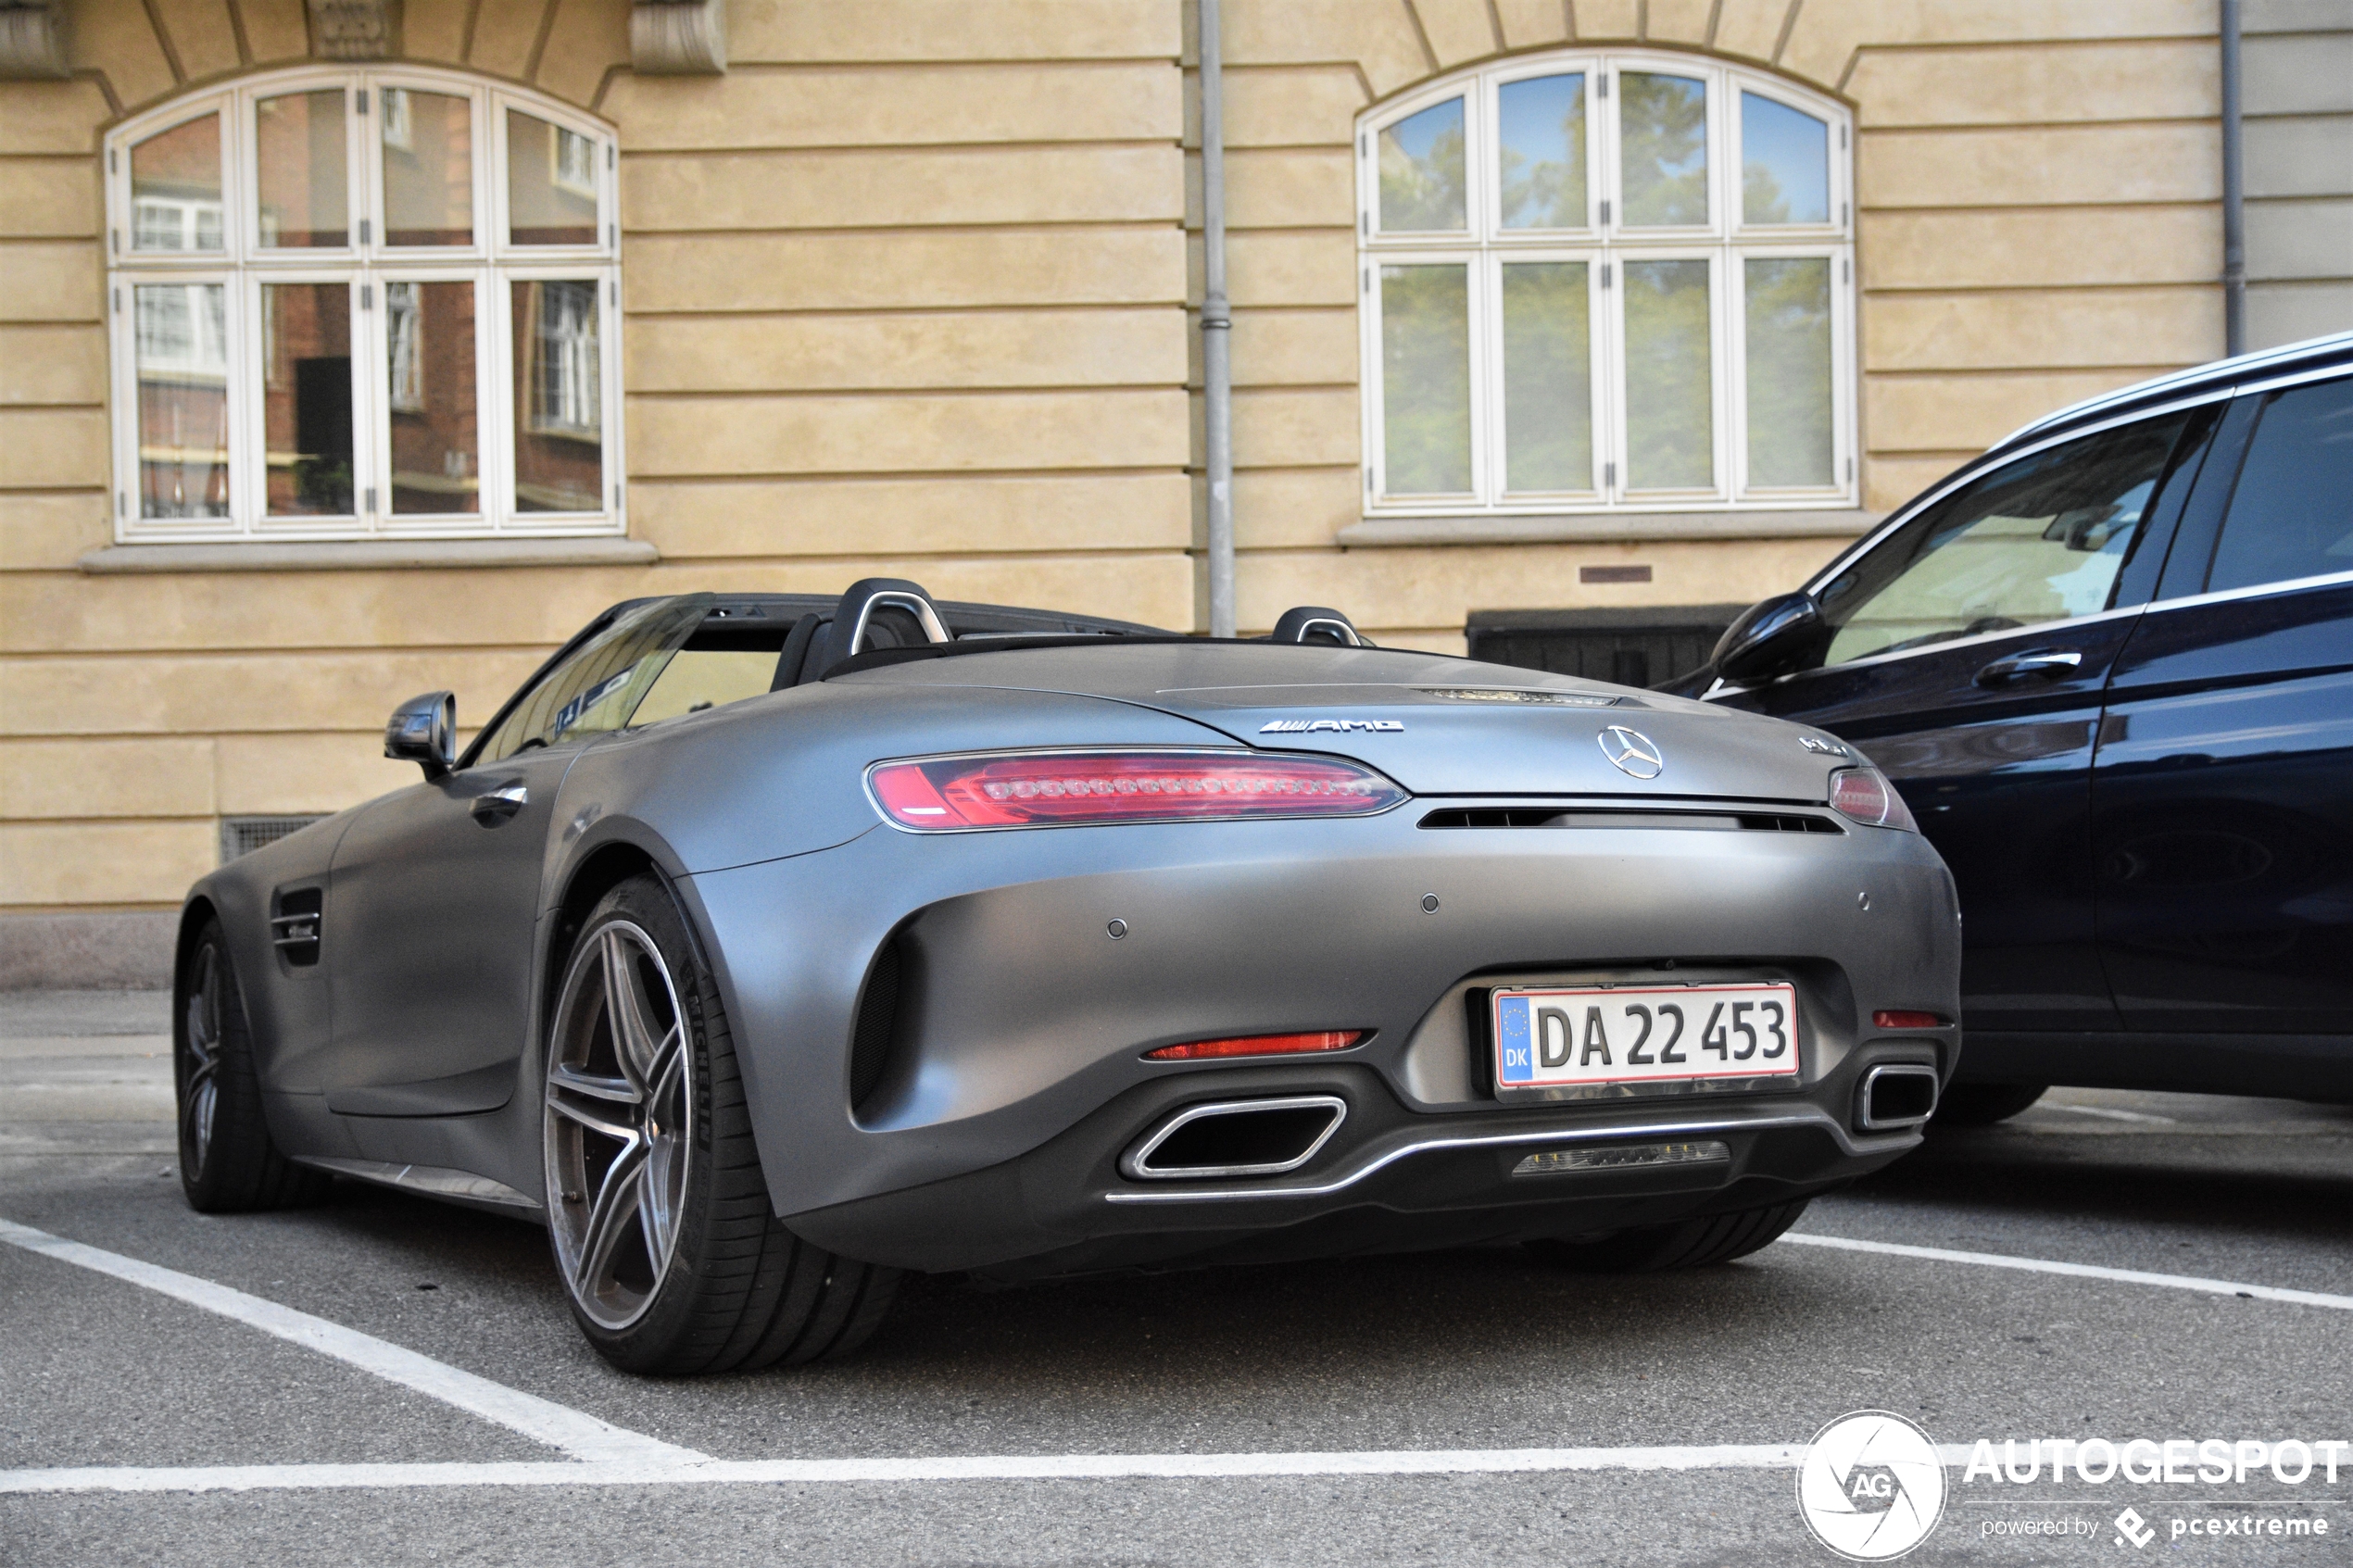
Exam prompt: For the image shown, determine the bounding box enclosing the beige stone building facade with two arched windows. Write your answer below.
[0,0,2353,983]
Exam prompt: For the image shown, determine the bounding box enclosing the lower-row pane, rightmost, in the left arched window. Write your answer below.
[510,278,605,512]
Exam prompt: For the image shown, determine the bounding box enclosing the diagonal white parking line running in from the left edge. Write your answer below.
[0,1220,703,1464]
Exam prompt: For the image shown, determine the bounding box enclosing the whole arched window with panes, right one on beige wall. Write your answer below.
[1358,52,1855,515]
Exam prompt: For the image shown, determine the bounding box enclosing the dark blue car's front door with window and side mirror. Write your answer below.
[1716,409,2214,1032]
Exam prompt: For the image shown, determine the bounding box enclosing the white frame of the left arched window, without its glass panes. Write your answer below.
[106,64,628,543]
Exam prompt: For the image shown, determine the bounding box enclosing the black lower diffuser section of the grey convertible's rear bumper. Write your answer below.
[788,1062,1925,1279]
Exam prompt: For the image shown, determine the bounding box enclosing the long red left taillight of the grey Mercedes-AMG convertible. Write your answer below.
[866,752,1404,833]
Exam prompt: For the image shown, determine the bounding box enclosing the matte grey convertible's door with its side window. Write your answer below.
[322,595,711,1117]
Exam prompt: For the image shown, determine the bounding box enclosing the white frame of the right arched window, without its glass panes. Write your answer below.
[1355,49,1859,517]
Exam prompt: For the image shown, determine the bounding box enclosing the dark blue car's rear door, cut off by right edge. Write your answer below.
[2092,367,2353,1048]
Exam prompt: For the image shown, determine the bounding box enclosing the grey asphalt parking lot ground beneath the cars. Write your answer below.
[0,995,2353,1568]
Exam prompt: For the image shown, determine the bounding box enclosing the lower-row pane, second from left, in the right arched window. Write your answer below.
[1504,261,1593,491]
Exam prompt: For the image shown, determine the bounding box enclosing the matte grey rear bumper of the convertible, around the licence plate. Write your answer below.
[683,799,1960,1270]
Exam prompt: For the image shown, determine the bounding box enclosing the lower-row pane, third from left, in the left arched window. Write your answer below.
[384,282,483,515]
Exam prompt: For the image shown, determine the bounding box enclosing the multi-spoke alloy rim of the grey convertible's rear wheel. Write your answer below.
[546,919,694,1328]
